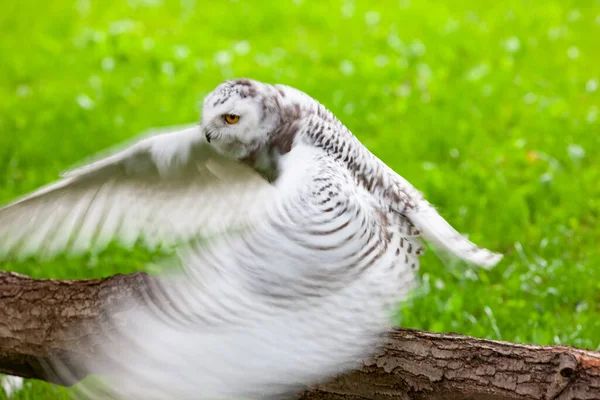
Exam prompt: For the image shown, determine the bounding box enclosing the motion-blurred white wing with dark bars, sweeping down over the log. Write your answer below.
[85,146,418,399]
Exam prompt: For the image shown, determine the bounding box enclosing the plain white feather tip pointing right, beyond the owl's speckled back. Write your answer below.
[406,204,502,268]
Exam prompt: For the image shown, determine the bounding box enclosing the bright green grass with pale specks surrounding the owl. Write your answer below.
[0,0,600,399]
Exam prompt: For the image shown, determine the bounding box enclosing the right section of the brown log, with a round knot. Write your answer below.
[301,328,600,400]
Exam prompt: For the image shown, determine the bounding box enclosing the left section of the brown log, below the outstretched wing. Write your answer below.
[0,271,151,385]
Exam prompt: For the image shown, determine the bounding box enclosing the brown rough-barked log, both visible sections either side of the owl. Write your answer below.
[0,272,600,400]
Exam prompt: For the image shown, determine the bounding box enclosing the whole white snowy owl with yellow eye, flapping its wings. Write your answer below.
[0,79,501,399]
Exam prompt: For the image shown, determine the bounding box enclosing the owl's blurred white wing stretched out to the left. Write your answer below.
[0,126,274,258]
